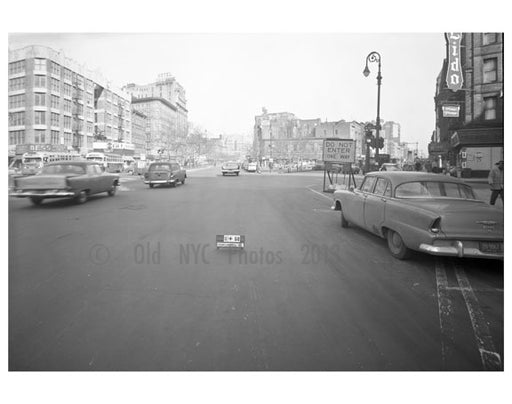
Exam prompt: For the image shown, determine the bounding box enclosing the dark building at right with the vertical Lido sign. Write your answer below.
[429,32,504,176]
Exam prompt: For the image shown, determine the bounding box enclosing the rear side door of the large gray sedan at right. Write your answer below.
[364,177,391,235]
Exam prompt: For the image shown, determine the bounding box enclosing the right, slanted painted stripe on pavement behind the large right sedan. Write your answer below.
[455,265,503,370]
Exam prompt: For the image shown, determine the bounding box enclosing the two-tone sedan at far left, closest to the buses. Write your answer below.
[10,161,119,205]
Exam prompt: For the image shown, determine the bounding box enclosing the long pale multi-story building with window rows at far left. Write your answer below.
[9,46,131,153]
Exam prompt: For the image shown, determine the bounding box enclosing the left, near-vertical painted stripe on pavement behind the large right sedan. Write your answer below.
[435,259,455,369]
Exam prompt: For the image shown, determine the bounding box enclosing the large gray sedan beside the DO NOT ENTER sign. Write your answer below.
[333,171,504,259]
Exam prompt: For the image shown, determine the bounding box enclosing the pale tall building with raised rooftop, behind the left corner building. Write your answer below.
[123,73,188,154]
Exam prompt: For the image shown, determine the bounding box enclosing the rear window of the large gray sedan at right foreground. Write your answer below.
[395,181,476,199]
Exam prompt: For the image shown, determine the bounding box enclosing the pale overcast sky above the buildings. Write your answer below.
[8,32,445,152]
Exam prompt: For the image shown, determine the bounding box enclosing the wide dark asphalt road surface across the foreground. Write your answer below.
[9,169,503,370]
